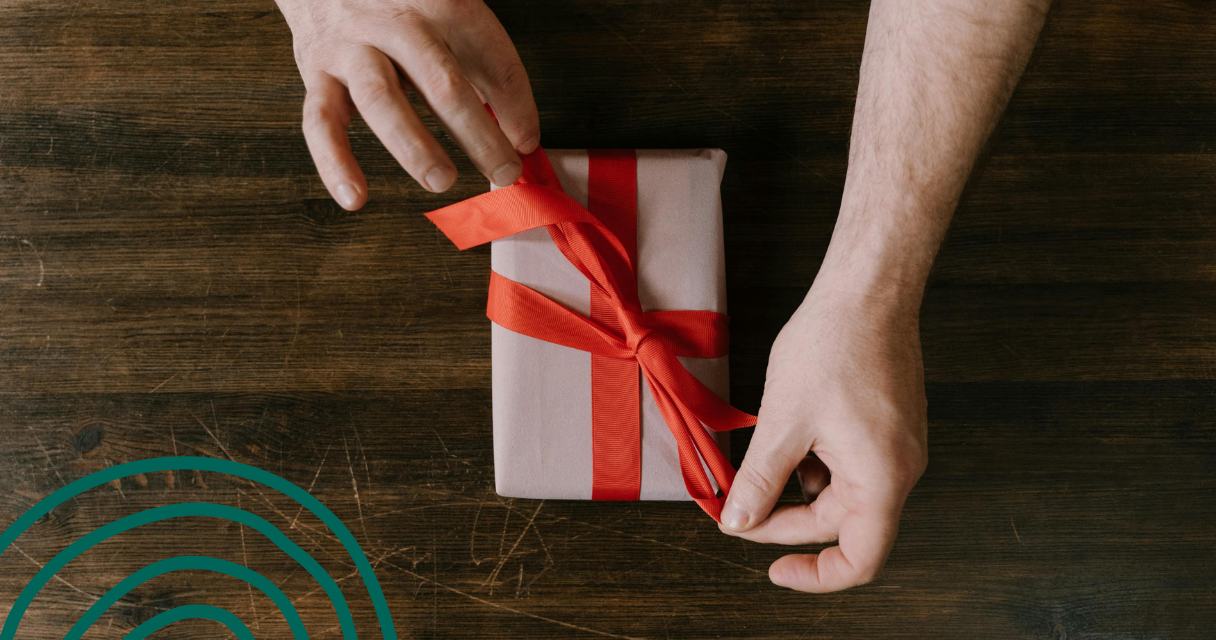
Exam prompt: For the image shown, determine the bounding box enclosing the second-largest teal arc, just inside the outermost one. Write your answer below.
[0,503,358,640]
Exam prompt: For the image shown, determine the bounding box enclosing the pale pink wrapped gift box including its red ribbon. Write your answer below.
[428,150,755,520]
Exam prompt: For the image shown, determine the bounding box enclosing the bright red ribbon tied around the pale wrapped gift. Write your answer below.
[427,148,756,521]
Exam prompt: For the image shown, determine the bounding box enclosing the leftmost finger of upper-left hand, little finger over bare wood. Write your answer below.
[303,73,367,210]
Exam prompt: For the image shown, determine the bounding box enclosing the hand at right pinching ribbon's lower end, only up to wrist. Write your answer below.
[721,273,927,593]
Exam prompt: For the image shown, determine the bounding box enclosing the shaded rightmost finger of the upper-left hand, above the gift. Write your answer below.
[447,2,540,153]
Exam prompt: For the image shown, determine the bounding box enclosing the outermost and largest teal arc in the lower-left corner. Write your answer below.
[0,456,396,640]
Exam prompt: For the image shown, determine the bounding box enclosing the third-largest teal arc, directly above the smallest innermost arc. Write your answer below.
[63,556,308,640]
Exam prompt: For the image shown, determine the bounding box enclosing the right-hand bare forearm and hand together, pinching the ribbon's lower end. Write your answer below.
[721,0,1051,593]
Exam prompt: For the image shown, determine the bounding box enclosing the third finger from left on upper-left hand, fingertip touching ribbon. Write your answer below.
[379,12,523,186]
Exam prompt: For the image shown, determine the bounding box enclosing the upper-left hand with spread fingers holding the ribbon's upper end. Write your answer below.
[278,0,540,210]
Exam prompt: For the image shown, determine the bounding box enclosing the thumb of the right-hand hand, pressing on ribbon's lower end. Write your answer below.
[721,419,810,533]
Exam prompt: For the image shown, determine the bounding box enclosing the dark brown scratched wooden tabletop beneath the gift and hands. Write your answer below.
[0,0,1216,640]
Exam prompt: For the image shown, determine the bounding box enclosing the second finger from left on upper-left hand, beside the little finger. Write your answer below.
[345,46,456,192]
